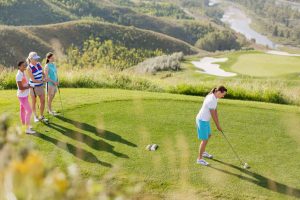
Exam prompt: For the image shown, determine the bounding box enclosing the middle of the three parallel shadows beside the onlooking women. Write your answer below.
[47,122,129,158]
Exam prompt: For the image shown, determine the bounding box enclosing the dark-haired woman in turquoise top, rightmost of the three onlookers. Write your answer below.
[45,52,59,115]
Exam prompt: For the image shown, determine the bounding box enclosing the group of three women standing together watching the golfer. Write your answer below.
[16,52,59,134]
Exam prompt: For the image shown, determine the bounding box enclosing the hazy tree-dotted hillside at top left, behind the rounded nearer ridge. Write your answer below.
[0,0,217,45]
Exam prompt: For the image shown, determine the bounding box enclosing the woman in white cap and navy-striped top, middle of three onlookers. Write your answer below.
[27,52,48,122]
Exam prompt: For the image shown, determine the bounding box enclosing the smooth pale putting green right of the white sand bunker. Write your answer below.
[231,53,300,77]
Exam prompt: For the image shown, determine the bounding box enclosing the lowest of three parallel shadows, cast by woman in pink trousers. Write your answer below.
[34,132,112,167]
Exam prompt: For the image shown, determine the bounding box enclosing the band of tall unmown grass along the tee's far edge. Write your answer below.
[0,68,300,105]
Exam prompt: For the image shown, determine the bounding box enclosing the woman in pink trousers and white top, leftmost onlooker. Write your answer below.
[16,61,35,134]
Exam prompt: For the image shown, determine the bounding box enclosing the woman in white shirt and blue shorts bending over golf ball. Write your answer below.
[196,86,227,166]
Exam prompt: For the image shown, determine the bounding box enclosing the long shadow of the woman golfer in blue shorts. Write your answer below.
[210,159,300,198]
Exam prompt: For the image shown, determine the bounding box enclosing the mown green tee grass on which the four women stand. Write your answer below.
[0,89,300,199]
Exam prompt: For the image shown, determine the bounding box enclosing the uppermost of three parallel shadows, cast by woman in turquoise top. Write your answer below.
[56,115,137,147]
